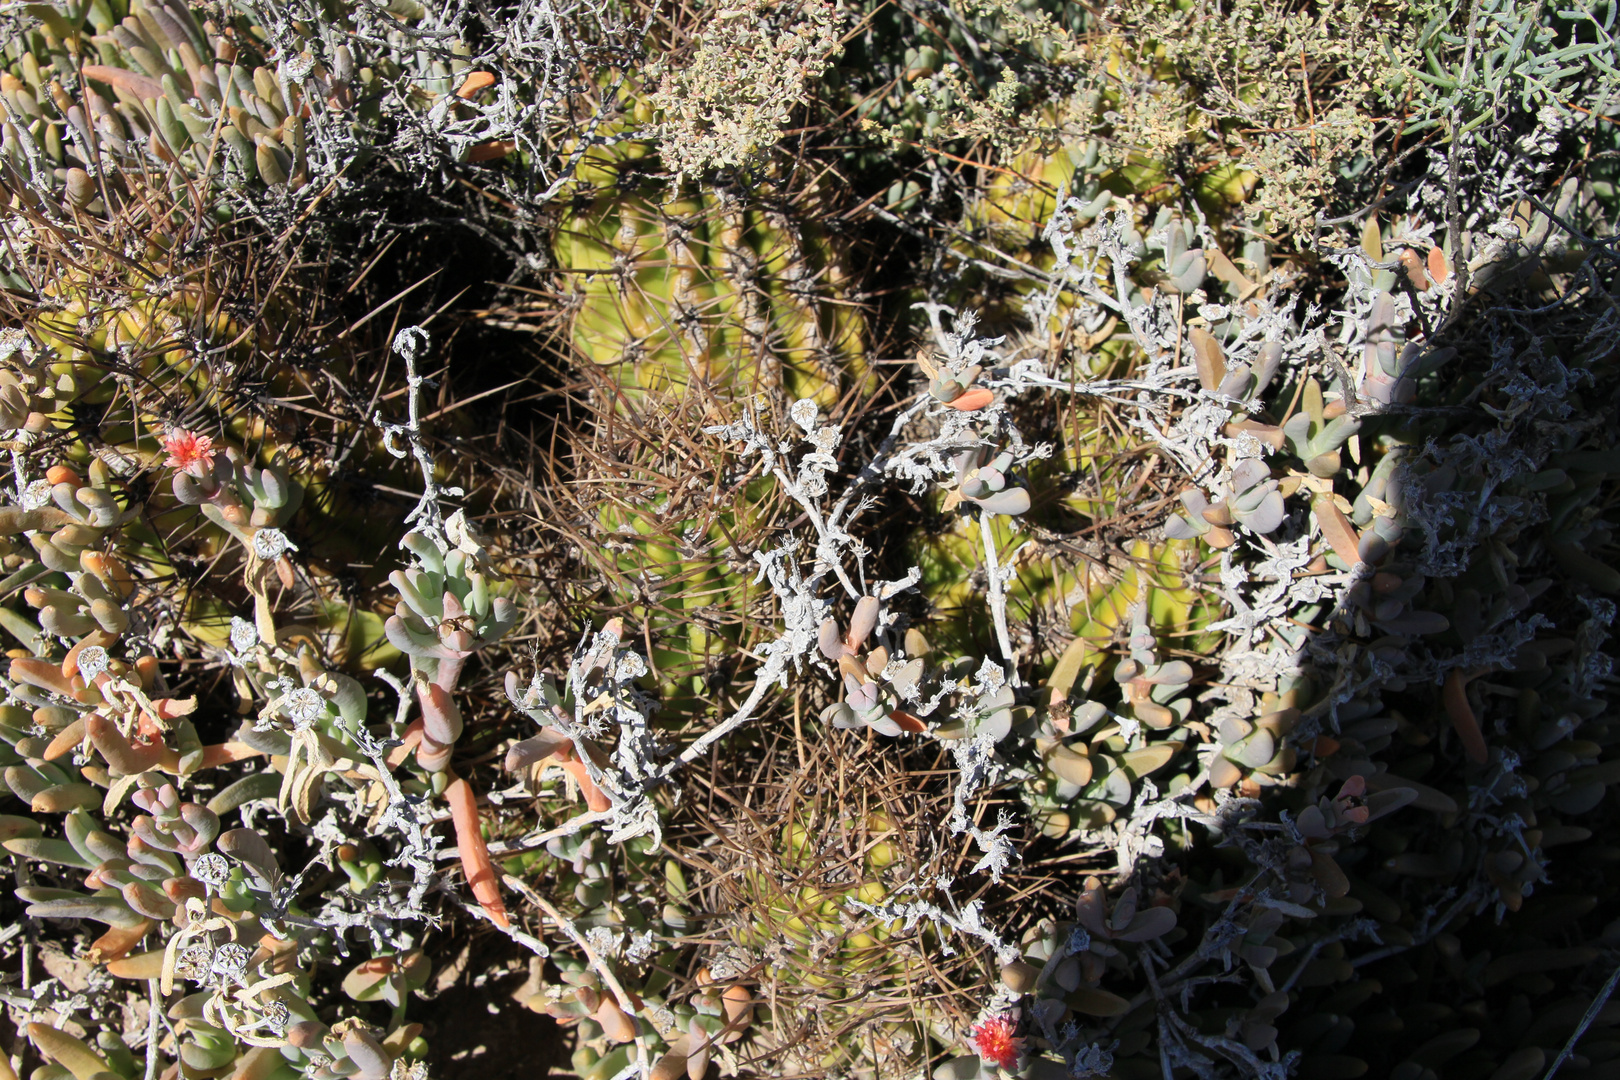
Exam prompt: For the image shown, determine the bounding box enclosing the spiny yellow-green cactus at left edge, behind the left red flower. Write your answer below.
[0,161,450,667]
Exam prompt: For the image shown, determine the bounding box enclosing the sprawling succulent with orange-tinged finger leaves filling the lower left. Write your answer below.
[0,283,489,1077]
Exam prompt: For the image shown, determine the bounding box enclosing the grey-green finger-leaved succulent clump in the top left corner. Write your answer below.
[0,0,570,214]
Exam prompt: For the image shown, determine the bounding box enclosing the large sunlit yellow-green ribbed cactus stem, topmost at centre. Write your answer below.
[552,131,870,408]
